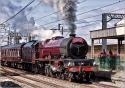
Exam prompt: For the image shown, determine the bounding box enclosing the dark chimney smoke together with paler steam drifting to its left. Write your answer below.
[42,0,77,34]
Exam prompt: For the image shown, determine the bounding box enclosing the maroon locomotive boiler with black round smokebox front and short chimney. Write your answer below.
[41,34,88,59]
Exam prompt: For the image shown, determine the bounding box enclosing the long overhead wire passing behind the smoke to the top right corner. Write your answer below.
[37,0,125,26]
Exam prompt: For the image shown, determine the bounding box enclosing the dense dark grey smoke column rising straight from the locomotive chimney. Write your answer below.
[58,0,77,34]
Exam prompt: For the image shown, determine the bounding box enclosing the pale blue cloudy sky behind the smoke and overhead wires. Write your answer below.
[0,0,125,44]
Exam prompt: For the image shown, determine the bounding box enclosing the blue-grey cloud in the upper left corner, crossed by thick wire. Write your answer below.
[0,0,35,35]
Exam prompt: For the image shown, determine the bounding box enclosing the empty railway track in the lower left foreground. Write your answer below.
[1,69,65,88]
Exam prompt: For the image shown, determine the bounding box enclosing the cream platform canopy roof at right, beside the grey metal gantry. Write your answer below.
[90,26,125,39]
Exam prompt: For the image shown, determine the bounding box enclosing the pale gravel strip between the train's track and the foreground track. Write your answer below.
[0,68,92,88]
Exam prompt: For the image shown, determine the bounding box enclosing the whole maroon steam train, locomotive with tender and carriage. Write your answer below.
[1,34,94,81]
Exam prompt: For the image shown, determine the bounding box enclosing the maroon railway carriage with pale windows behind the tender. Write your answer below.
[1,43,24,67]
